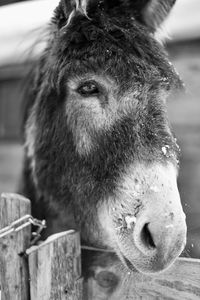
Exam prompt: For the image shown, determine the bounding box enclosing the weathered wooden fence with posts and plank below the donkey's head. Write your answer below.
[0,194,200,300]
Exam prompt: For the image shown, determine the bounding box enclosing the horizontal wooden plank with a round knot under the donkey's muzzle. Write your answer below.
[84,258,200,300]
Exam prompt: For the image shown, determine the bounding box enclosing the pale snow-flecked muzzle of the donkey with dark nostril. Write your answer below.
[99,165,187,273]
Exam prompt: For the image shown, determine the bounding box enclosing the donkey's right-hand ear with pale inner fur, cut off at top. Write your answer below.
[140,0,176,32]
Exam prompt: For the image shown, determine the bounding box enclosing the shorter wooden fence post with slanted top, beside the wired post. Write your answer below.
[27,230,82,300]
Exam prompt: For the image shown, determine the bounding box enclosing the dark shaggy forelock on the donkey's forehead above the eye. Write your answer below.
[50,10,182,89]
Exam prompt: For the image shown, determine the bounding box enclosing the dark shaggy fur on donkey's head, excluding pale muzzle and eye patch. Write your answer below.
[21,1,181,276]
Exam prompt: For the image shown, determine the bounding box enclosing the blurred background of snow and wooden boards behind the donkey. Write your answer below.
[0,0,200,258]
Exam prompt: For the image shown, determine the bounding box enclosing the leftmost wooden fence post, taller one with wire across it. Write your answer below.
[0,194,31,300]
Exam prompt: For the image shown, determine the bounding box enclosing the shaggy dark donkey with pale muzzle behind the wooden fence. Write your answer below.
[21,0,186,273]
